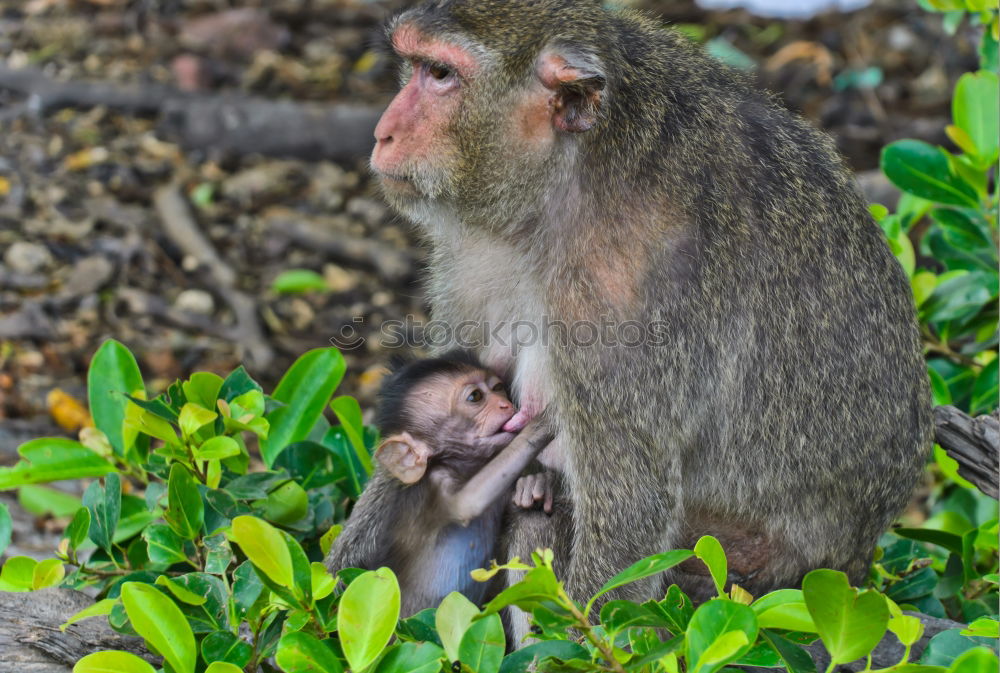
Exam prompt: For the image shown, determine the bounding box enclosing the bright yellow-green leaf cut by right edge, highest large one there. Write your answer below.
[951,70,1000,163]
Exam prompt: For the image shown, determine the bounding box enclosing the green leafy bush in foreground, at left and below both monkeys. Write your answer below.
[0,341,997,673]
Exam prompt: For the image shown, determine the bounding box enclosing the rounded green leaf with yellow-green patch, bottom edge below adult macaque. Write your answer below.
[685,598,757,673]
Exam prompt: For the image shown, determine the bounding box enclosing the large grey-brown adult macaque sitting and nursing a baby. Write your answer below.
[371,0,931,599]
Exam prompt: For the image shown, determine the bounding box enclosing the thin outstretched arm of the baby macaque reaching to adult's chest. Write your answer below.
[440,420,554,525]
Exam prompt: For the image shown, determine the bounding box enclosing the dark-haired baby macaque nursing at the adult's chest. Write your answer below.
[326,351,553,616]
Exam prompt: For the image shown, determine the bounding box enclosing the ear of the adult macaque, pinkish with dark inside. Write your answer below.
[538,46,607,133]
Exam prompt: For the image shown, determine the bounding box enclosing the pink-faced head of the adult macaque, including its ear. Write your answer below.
[371,12,605,230]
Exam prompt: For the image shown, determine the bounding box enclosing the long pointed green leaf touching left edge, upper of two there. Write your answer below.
[0,437,115,491]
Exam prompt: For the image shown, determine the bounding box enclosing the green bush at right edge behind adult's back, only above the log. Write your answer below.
[872,0,1000,415]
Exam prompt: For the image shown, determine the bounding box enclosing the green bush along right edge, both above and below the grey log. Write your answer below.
[872,0,1000,632]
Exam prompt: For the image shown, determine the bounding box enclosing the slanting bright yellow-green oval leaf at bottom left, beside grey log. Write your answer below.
[121,582,198,673]
